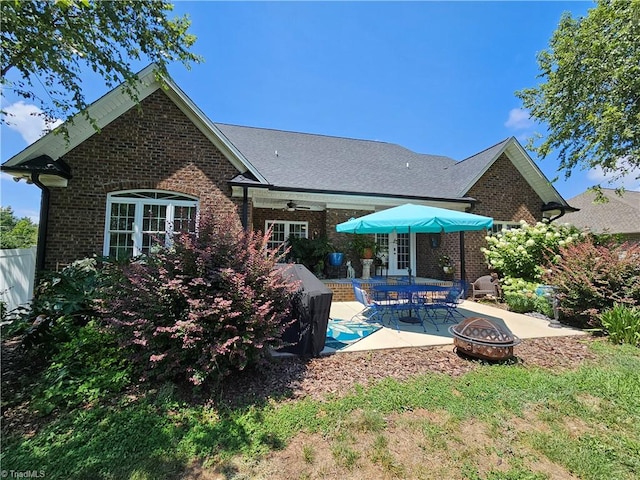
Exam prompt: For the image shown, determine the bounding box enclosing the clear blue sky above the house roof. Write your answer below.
[0,1,640,219]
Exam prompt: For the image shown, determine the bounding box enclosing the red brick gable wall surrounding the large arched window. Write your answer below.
[45,90,241,269]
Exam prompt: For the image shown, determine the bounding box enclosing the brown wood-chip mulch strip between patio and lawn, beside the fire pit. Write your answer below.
[221,336,598,404]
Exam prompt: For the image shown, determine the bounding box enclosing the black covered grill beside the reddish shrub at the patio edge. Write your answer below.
[278,264,333,356]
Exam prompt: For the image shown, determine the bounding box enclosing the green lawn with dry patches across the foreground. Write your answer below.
[1,342,640,480]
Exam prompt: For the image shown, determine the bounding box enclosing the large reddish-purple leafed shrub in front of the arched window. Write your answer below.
[103,217,298,385]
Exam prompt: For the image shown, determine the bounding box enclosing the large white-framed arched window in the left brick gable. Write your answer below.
[103,190,198,259]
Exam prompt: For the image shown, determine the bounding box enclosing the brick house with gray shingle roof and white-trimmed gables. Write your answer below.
[2,66,572,288]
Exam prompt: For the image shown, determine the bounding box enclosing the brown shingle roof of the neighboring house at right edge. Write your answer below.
[561,188,640,234]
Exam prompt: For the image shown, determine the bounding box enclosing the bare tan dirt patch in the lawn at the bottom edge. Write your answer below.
[255,412,577,480]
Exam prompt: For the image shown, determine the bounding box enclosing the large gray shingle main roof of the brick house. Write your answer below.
[215,123,504,198]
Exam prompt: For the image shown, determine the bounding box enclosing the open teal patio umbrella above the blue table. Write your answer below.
[336,203,493,279]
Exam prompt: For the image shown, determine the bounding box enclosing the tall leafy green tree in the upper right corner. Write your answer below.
[516,0,640,189]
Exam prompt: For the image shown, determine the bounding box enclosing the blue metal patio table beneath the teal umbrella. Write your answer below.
[371,283,450,332]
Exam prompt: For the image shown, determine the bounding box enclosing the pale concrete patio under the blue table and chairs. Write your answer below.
[322,300,585,354]
